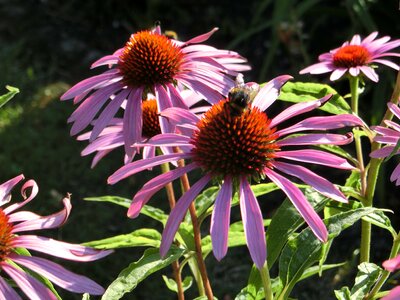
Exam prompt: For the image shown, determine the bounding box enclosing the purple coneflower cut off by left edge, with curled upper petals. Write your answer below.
[0,175,112,299]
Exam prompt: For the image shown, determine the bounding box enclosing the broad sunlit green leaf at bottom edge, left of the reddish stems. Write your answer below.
[101,246,185,300]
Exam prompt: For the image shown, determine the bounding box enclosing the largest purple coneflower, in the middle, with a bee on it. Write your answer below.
[108,76,362,268]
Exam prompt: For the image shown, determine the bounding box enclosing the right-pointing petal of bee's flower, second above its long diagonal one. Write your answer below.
[275,149,355,170]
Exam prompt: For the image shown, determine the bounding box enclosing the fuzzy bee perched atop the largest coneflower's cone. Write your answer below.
[226,74,260,117]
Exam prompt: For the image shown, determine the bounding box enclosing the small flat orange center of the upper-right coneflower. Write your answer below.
[333,45,371,68]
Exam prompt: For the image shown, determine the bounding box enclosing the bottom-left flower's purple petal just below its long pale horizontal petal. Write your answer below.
[10,254,104,295]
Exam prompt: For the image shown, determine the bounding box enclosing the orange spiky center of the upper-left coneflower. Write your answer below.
[118,31,183,88]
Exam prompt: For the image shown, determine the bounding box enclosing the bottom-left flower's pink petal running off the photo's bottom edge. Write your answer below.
[0,262,57,300]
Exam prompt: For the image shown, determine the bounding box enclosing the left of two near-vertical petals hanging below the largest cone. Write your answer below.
[210,176,232,261]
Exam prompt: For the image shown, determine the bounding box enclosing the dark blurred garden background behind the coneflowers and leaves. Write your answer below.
[0,0,400,299]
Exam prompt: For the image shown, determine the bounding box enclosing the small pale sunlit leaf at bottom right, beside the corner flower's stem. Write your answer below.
[351,263,382,300]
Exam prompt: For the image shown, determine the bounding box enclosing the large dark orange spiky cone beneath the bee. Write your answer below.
[191,100,279,178]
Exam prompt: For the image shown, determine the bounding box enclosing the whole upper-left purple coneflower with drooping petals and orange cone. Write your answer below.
[61,26,249,156]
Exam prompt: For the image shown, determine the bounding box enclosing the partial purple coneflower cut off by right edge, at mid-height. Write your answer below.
[370,103,400,185]
